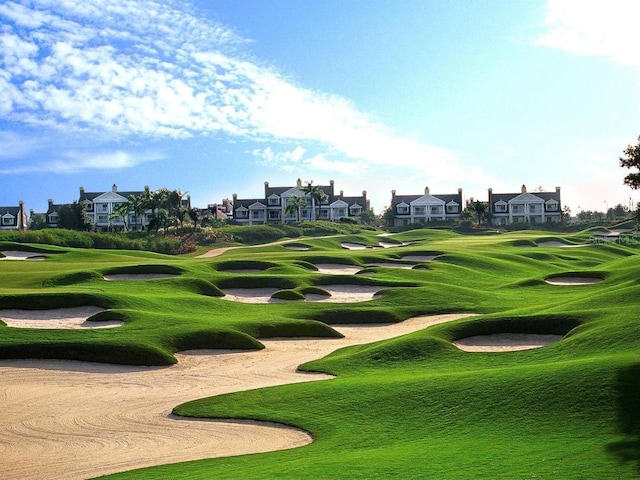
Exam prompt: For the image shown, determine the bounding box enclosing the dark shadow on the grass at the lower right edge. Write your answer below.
[607,363,640,473]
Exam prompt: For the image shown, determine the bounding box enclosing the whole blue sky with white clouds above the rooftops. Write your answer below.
[0,0,640,213]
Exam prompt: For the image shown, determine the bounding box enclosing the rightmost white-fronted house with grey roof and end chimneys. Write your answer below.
[489,185,562,225]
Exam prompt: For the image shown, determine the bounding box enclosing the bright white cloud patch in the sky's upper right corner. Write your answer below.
[535,0,640,68]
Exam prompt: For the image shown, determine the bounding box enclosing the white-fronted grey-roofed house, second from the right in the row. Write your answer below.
[390,187,464,227]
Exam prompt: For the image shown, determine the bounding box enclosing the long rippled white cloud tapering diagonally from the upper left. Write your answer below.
[0,0,463,176]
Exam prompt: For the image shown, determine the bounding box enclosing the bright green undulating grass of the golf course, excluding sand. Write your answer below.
[0,230,640,479]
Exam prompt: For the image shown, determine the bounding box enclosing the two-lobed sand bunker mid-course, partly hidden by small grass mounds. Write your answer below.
[222,285,385,303]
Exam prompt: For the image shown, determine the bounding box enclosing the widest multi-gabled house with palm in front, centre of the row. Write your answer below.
[233,179,370,225]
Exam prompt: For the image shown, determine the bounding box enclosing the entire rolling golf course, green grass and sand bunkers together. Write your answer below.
[0,229,640,480]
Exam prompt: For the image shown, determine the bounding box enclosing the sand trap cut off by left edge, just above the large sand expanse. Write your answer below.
[0,307,123,329]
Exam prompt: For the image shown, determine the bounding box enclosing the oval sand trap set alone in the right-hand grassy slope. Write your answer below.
[453,333,563,352]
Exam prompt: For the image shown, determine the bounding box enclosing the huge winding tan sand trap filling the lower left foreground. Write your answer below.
[0,315,468,480]
